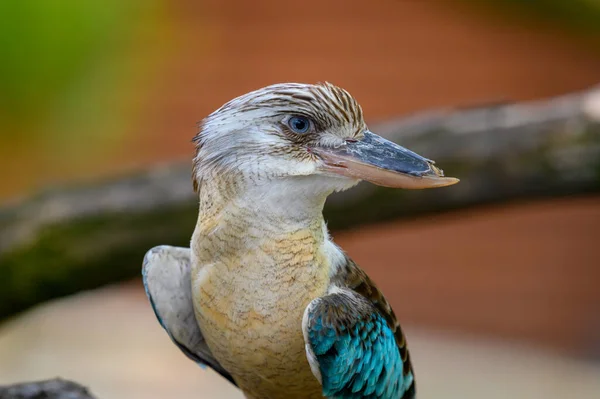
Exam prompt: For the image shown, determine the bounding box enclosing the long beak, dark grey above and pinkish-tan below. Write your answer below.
[312,131,459,189]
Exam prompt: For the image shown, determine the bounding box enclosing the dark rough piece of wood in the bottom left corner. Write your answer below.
[0,378,94,399]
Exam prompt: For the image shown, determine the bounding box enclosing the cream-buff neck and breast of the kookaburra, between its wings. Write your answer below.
[191,179,333,398]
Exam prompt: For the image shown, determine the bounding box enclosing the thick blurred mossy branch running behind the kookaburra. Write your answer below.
[0,89,600,319]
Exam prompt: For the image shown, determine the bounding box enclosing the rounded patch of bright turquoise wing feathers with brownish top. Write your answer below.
[306,294,413,399]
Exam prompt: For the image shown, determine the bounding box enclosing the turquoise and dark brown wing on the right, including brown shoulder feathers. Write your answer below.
[302,257,415,399]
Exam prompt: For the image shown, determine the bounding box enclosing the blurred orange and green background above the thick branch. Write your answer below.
[0,0,600,199]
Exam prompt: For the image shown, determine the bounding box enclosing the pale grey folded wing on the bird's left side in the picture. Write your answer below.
[142,245,235,385]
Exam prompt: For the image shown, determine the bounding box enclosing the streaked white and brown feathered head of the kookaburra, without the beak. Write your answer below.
[194,83,367,189]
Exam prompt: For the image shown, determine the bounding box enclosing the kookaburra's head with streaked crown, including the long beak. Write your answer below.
[193,83,458,198]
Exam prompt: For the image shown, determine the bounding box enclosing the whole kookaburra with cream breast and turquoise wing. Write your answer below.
[142,82,458,399]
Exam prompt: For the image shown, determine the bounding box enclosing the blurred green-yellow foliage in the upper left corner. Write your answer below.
[0,0,170,197]
